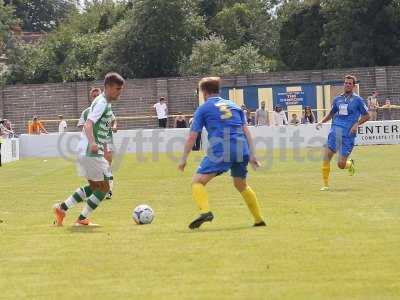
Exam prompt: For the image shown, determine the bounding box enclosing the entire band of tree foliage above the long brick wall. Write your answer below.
[0,0,400,83]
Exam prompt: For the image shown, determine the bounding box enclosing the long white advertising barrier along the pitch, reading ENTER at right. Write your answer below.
[20,121,400,157]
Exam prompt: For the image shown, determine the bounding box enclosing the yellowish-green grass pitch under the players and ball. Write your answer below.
[0,146,400,299]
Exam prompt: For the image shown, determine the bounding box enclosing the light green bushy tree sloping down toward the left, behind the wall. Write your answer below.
[7,0,125,83]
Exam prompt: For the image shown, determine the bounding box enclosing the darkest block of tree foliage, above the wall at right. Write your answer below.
[279,0,400,69]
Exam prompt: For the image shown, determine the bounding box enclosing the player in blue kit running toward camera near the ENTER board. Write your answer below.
[317,75,370,191]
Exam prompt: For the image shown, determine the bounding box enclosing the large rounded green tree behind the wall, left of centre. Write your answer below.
[98,0,206,77]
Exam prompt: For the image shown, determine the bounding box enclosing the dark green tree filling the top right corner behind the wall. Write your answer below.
[322,0,400,68]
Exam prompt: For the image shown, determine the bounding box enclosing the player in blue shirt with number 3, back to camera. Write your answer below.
[178,77,266,229]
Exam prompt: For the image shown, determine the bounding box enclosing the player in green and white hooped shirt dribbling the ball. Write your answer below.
[53,73,125,226]
